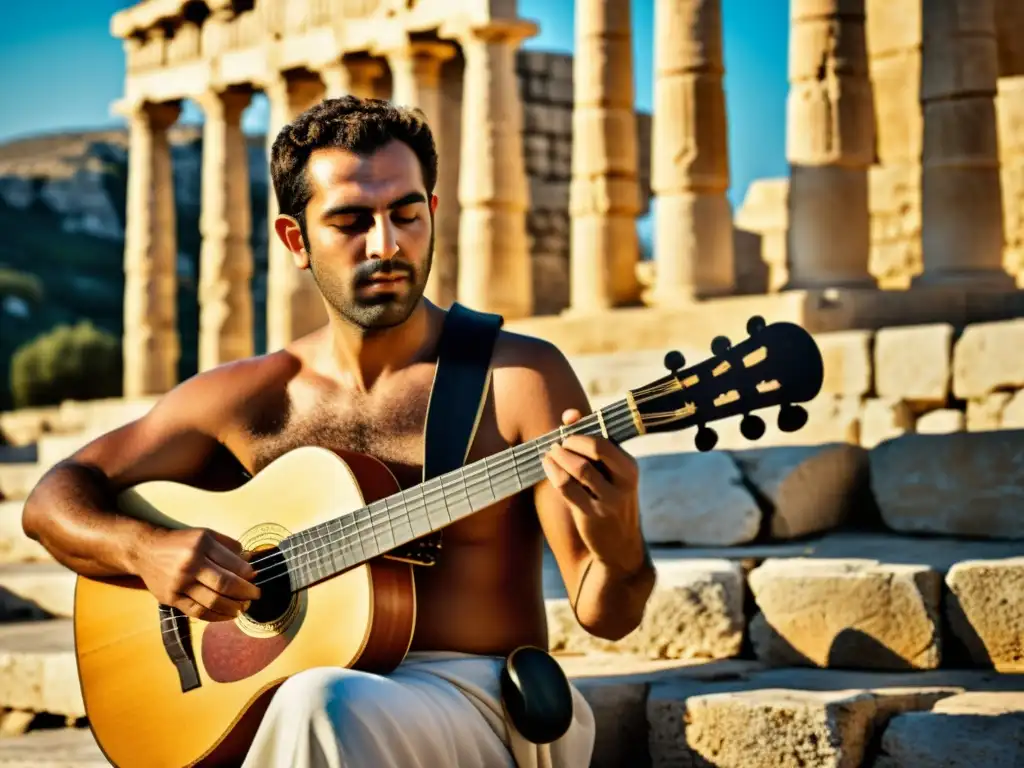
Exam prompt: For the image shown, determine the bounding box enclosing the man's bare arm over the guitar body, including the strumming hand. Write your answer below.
[22,364,259,618]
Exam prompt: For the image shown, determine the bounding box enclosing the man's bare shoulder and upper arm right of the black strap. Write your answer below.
[493,331,591,440]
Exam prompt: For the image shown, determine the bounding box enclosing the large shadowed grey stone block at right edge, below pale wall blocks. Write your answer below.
[869,430,1024,539]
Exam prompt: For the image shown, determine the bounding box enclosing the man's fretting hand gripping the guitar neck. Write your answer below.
[542,409,645,573]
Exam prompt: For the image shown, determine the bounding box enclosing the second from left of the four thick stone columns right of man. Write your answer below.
[648,0,735,306]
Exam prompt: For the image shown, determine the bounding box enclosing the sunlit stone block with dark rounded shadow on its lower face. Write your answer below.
[749,558,942,670]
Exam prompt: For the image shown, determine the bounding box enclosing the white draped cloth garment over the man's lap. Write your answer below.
[243,651,594,768]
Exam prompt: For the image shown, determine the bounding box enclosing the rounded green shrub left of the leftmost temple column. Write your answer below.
[10,321,123,408]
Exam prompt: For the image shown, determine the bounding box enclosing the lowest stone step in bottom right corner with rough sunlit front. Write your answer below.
[647,669,1024,768]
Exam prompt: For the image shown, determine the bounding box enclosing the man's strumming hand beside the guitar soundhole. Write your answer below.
[137,528,260,622]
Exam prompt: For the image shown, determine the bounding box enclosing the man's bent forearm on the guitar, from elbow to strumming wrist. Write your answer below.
[22,462,153,577]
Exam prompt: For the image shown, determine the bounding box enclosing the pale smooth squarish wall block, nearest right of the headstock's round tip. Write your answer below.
[874,323,953,408]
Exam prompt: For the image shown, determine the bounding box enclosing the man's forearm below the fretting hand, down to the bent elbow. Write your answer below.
[574,547,656,640]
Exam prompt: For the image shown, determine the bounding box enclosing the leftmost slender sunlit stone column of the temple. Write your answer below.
[122,102,181,397]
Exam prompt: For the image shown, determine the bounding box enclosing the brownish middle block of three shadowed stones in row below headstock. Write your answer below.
[732,443,869,539]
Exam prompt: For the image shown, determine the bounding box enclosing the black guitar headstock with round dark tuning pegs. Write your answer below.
[630,316,824,451]
